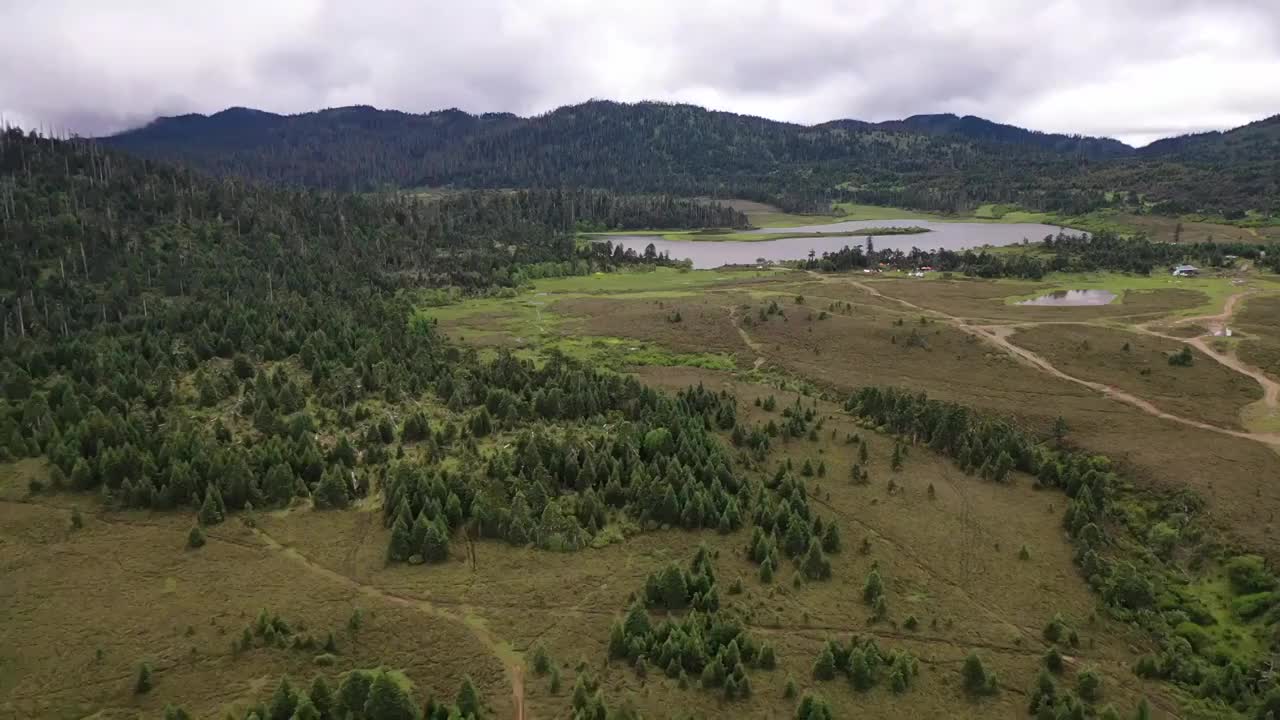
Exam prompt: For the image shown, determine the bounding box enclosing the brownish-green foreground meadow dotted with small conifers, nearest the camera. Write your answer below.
[0,379,1161,719]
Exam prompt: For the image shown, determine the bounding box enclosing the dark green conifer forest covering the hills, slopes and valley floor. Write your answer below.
[0,102,1280,720]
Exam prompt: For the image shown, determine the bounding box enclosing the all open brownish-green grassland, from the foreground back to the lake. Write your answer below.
[10,263,1280,719]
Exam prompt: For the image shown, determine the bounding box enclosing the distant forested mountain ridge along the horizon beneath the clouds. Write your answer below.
[106,101,1280,218]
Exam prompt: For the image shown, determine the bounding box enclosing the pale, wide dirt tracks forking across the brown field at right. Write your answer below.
[810,272,1280,446]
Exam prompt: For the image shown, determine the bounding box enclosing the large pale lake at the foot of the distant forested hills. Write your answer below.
[599,220,1071,269]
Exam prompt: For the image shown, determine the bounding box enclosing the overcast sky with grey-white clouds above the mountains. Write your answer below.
[0,0,1280,143]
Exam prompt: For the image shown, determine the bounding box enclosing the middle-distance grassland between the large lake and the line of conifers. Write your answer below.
[422,263,1280,556]
